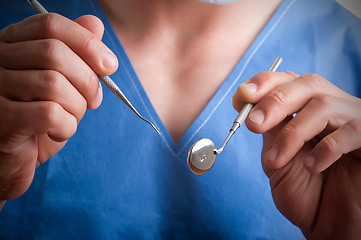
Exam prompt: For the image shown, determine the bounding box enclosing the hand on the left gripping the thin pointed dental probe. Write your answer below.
[0,14,118,201]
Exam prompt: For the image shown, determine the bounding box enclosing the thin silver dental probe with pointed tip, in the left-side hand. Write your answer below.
[27,0,160,135]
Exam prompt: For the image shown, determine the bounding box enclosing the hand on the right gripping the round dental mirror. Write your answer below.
[233,72,361,239]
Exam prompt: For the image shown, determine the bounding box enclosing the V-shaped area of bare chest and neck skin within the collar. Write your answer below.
[100,0,281,143]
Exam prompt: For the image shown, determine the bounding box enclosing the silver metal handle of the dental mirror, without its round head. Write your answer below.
[213,57,283,155]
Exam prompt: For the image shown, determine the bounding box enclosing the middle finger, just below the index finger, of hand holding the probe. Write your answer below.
[0,39,102,109]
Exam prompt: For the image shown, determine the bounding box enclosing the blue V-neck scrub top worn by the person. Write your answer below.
[0,0,361,239]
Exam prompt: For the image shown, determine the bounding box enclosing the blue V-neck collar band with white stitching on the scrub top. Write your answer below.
[88,0,297,157]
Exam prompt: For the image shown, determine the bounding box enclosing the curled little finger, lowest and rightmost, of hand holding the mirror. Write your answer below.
[305,119,361,173]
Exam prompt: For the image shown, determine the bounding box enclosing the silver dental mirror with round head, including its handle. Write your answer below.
[187,57,283,175]
